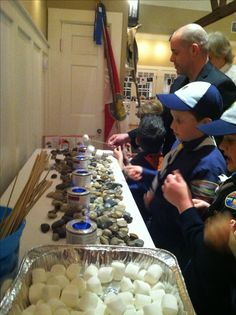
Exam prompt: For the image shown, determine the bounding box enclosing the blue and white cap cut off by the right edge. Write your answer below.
[197,101,236,136]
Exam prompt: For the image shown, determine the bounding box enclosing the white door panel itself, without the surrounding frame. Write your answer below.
[61,23,104,135]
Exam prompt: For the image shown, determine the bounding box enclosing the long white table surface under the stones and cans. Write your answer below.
[0,149,155,260]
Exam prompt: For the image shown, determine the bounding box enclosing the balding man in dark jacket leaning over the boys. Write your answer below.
[108,24,236,155]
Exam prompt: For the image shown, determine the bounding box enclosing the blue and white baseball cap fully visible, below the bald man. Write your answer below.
[157,81,223,120]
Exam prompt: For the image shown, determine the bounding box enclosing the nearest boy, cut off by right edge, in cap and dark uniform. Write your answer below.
[163,102,236,315]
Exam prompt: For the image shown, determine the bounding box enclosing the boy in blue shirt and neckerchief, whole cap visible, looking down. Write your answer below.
[145,82,226,270]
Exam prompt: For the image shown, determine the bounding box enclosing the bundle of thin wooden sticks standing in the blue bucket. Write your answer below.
[0,151,52,239]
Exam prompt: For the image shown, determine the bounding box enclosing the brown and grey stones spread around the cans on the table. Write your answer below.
[41,150,144,247]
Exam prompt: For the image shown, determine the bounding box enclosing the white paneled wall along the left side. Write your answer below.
[0,0,48,195]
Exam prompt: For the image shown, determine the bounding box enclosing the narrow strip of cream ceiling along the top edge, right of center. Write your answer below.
[140,0,230,12]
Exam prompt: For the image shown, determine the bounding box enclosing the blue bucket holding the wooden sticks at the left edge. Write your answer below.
[0,206,25,283]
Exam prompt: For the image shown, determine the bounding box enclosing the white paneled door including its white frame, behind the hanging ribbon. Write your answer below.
[45,9,122,140]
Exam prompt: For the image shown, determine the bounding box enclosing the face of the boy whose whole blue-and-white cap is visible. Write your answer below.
[170,110,203,141]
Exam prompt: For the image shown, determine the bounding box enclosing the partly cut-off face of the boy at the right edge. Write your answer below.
[219,134,236,172]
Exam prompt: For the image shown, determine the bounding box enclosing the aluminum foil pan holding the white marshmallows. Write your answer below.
[0,244,196,315]
